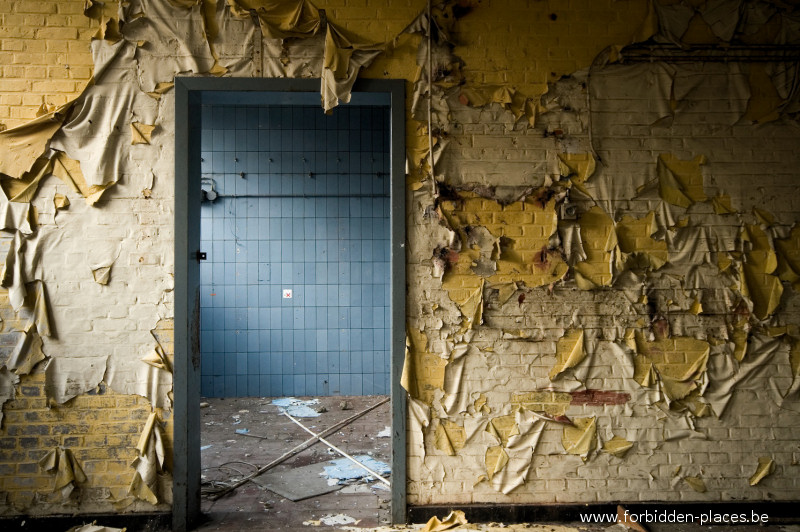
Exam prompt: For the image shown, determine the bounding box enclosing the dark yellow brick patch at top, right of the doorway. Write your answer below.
[454,0,647,97]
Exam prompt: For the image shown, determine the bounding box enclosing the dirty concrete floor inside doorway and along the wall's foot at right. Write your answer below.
[196,396,800,532]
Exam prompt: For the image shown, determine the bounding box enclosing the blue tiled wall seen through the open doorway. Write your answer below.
[200,105,389,397]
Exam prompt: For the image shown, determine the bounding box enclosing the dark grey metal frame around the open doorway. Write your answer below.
[172,77,406,531]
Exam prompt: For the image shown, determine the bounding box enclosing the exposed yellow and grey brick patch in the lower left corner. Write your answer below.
[0,373,158,514]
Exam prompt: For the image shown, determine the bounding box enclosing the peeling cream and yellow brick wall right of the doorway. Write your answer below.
[408,3,799,504]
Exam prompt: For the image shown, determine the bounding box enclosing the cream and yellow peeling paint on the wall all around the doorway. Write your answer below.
[0,0,800,526]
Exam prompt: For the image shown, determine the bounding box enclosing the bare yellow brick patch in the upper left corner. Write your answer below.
[0,0,97,128]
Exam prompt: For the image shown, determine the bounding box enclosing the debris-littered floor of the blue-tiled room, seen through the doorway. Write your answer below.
[199,396,391,532]
